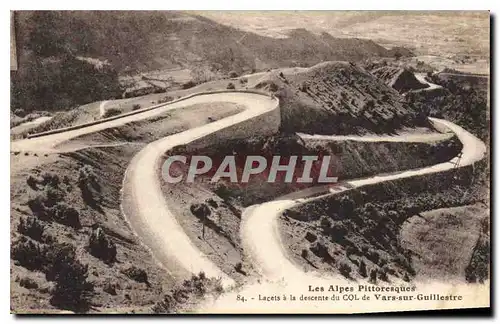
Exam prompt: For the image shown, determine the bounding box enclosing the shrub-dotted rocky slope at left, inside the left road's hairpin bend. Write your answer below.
[10,105,238,313]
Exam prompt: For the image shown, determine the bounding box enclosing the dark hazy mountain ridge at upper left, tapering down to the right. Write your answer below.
[11,11,412,111]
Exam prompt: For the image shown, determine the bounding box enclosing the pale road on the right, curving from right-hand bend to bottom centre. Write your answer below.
[241,118,486,280]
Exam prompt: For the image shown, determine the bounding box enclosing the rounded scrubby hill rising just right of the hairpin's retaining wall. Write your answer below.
[255,62,428,135]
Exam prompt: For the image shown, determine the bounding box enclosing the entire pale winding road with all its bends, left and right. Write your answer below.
[11,85,486,308]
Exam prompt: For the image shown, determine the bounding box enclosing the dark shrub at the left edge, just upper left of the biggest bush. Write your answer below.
[10,236,45,270]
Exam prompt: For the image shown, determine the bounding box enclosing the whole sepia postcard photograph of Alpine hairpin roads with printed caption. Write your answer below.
[9,10,492,315]
